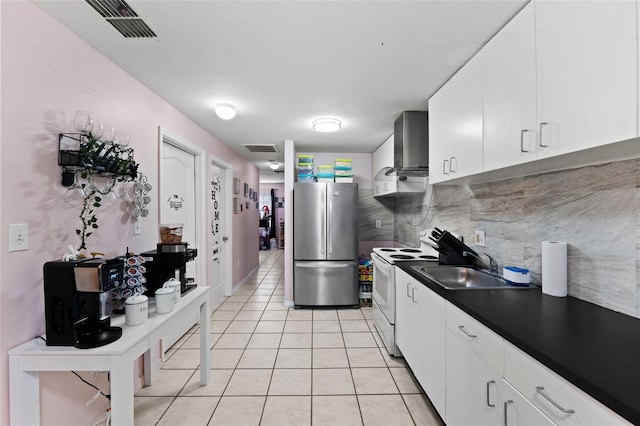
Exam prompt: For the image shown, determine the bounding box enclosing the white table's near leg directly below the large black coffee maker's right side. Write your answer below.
[111,356,133,426]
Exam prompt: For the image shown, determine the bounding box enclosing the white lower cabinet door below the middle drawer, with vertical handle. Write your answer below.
[446,330,503,426]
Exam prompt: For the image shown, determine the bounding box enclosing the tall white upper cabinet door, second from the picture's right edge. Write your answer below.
[482,3,537,171]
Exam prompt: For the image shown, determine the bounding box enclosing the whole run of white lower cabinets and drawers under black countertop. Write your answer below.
[395,278,630,426]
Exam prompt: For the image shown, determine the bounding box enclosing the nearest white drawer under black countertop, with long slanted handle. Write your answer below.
[504,342,629,425]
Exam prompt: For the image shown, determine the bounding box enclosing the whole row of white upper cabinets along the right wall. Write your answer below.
[429,0,640,183]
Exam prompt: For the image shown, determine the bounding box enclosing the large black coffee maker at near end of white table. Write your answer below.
[43,258,124,349]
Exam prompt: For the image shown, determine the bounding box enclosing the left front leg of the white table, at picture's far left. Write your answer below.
[9,356,40,425]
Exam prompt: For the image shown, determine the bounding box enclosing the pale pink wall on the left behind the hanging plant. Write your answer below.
[0,2,258,425]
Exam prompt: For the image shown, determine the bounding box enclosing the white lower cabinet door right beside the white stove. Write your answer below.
[396,267,446,418]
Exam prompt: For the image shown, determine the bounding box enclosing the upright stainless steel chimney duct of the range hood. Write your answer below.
[387,111,429,176]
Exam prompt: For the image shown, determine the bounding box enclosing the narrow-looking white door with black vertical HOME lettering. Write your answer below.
[208,164,226,301]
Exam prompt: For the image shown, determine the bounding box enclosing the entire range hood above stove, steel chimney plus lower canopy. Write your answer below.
[373,111,429,197]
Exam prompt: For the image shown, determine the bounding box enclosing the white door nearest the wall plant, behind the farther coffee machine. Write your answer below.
[160,142,202,284]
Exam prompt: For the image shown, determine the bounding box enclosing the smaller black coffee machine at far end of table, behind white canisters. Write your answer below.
[141,242,198,296]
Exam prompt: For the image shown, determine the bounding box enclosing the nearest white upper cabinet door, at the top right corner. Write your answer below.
[535,0,638,158]
